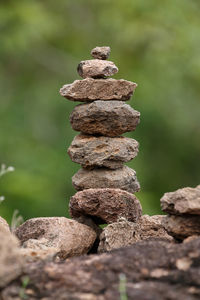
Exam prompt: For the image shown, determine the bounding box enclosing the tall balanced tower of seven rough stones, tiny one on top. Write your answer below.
[60,47,142,224]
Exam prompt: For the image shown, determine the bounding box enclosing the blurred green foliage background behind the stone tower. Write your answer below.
[0,0,200,225]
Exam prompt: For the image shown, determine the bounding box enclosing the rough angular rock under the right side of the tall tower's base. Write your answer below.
[98,215,173,253]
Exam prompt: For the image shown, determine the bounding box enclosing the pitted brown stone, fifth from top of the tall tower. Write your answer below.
[68,134,139,169]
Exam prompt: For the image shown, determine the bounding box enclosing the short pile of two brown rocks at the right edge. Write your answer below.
[161,185,200,240]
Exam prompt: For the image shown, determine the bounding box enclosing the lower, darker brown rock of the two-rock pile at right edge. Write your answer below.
[162,215,200,240]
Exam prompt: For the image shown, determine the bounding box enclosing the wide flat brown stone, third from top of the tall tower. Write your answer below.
[60,78,137,102]
